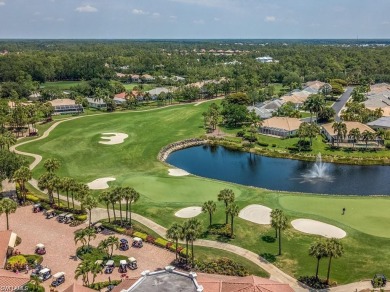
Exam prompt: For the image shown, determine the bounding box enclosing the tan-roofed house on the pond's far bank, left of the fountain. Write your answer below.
[260,117,302,137]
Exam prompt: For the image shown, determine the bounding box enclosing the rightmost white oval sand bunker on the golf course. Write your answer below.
[291,219,347,238]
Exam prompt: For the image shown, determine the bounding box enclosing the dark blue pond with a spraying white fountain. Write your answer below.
[166,145,390,195]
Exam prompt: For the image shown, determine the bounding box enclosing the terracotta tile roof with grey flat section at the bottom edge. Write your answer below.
[112,267,294,292]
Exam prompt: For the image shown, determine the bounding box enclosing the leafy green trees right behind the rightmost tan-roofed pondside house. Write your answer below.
[340,101,383,124]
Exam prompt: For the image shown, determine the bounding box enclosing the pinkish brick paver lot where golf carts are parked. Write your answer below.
[0,206,175,291]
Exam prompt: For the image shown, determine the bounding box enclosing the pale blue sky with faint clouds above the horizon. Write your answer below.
[0,0,390,39]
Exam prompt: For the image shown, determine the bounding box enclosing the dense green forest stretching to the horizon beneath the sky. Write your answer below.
[0,40,390,97]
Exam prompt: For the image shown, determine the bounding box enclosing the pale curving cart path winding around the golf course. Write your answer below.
[10,103,372,292]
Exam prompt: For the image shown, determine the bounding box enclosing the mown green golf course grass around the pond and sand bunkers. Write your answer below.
[18,99,390,283]
